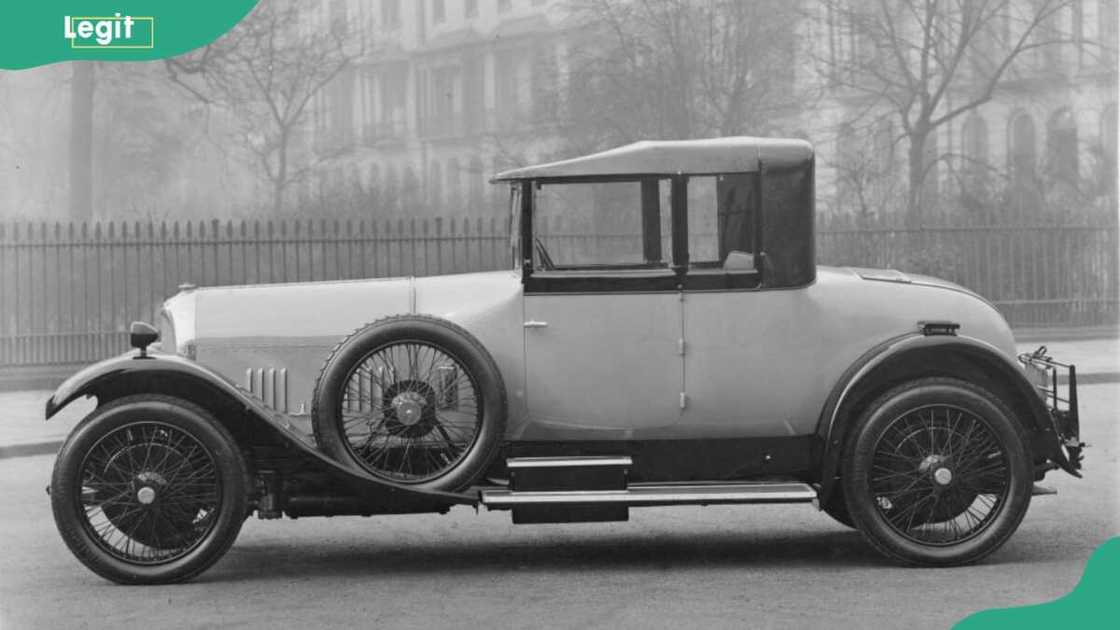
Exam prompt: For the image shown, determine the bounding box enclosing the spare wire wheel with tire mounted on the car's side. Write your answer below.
[311,315,506,491]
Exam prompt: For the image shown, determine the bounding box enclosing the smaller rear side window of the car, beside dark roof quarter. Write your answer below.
[688,173,758,272]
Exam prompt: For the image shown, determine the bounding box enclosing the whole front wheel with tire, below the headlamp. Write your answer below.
[50,395,250,584]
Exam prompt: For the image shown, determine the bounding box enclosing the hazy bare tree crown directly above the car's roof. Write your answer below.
[560,0,797,150]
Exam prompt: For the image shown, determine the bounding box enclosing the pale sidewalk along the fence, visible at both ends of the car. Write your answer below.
[0,337,1120,457]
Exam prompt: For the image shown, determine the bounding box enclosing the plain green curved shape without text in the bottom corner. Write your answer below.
[953,537,1120,630]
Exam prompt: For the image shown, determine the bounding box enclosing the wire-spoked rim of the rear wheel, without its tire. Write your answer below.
[867,405,1011,546]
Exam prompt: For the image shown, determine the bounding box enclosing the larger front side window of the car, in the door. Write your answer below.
[533,178,671,271]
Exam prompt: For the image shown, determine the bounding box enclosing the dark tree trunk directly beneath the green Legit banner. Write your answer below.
[69,62,95,221]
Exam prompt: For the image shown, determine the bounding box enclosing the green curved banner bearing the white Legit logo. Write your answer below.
[0,0,256,70]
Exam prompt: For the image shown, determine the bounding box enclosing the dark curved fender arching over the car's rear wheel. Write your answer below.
[816,333,1066,506]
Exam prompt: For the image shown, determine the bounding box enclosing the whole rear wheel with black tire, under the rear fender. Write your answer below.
[840,378,1033,566]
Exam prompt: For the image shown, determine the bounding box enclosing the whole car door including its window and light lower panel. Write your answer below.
[519,178,683,441]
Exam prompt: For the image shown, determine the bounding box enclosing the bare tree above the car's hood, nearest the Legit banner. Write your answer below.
[165,0,364,213]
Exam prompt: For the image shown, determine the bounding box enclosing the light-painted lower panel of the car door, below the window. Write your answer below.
[525,293,683,439]
